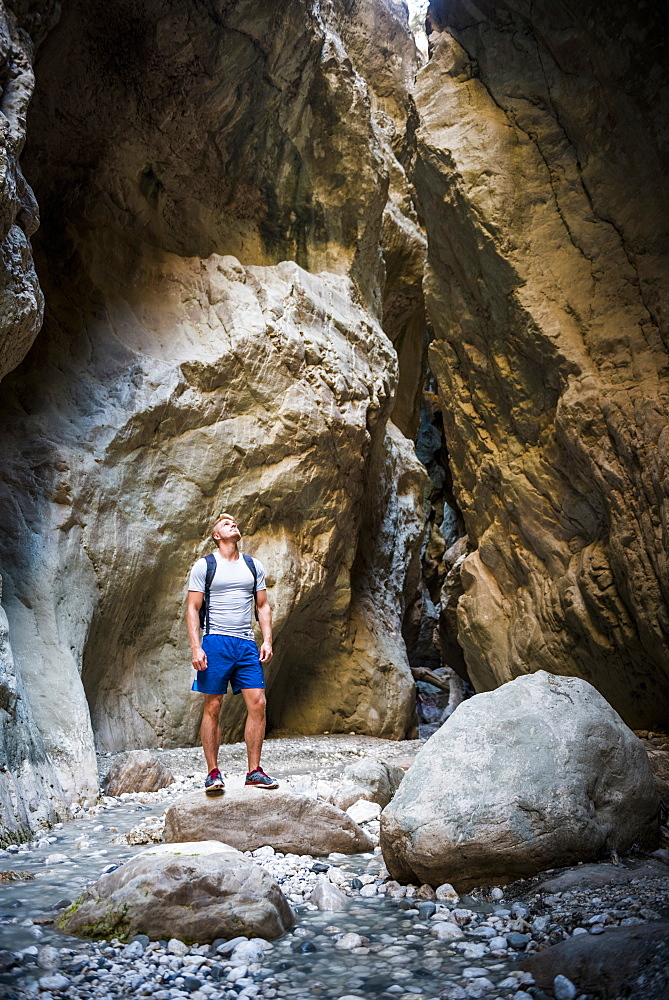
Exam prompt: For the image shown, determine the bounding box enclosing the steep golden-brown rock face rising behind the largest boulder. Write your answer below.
[414,0,669,727]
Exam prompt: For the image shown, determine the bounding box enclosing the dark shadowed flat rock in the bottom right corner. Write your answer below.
[521,921,669,1000]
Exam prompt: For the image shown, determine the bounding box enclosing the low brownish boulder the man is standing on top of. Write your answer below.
[165,788,374,856]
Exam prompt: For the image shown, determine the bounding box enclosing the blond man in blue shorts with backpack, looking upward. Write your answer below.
[186,514,279,795]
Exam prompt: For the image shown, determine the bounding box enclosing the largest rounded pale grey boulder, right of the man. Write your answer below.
[381,670,659,891]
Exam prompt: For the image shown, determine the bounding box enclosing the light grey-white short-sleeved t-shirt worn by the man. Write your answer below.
[188,552,266,641]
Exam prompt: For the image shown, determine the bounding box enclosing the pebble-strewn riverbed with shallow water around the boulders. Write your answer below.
[0,735,669,1000]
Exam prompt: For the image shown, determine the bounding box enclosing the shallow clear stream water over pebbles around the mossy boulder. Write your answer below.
[0,776,528,1000]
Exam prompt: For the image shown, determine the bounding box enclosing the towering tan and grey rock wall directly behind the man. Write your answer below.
[0,0,426,820]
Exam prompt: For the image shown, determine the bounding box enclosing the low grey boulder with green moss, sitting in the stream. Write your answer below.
[58,842,295,943]
